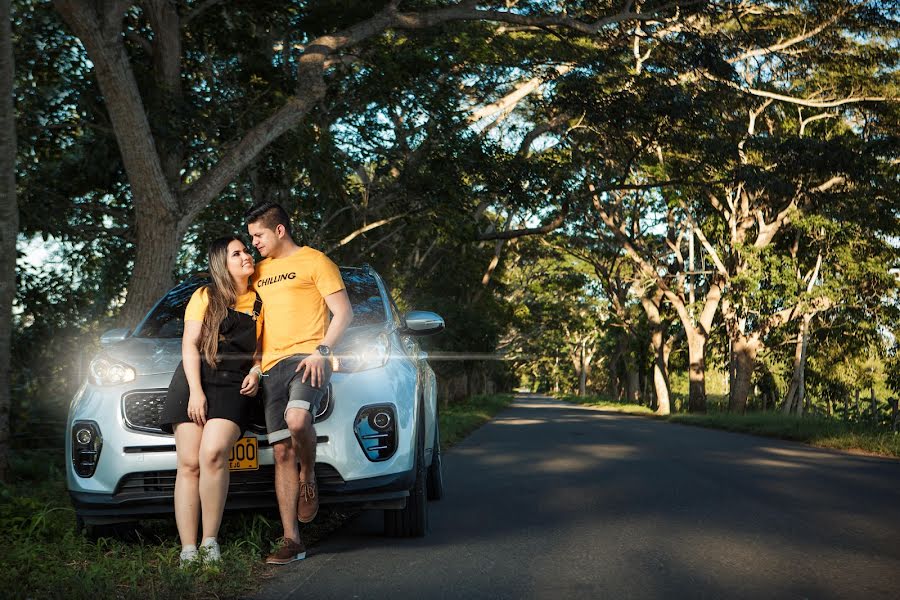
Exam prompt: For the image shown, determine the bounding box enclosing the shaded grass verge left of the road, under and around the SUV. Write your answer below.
[0,396,512,600]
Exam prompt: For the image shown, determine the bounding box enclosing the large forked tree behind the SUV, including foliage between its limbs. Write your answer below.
[47,0,693,322]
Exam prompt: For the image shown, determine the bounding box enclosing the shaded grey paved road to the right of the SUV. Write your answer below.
[251,397,900,600]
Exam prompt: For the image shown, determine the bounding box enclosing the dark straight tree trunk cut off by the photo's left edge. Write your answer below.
[0,0,19,481]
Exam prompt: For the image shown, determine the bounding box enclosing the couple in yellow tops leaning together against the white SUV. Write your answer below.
[160,202,353,565]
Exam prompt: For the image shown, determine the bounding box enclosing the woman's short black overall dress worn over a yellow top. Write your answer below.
[159,294,262,433]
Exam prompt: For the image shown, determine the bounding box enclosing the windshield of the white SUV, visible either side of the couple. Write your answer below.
[134,267,386,338]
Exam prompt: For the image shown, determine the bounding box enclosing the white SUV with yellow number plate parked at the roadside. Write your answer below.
[66,266,444,537]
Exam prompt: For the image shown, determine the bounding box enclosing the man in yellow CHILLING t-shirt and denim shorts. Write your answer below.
[245,202,353,565]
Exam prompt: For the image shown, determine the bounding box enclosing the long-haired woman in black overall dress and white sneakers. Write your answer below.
[160,236,262,565]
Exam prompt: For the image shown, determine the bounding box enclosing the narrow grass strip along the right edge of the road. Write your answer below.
[557,395,900,458]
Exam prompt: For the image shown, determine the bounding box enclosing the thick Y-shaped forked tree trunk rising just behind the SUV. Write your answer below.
[54,0,325,327]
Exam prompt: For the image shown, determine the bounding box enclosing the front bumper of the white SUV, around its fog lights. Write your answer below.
[66,360,426,519]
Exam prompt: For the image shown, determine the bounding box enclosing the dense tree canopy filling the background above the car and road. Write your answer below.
[11,0,900,474]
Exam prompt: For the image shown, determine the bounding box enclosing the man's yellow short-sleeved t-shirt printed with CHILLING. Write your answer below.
[252,246,344,371]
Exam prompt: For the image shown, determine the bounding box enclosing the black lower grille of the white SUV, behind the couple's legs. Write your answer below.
[115,463,344,498]
